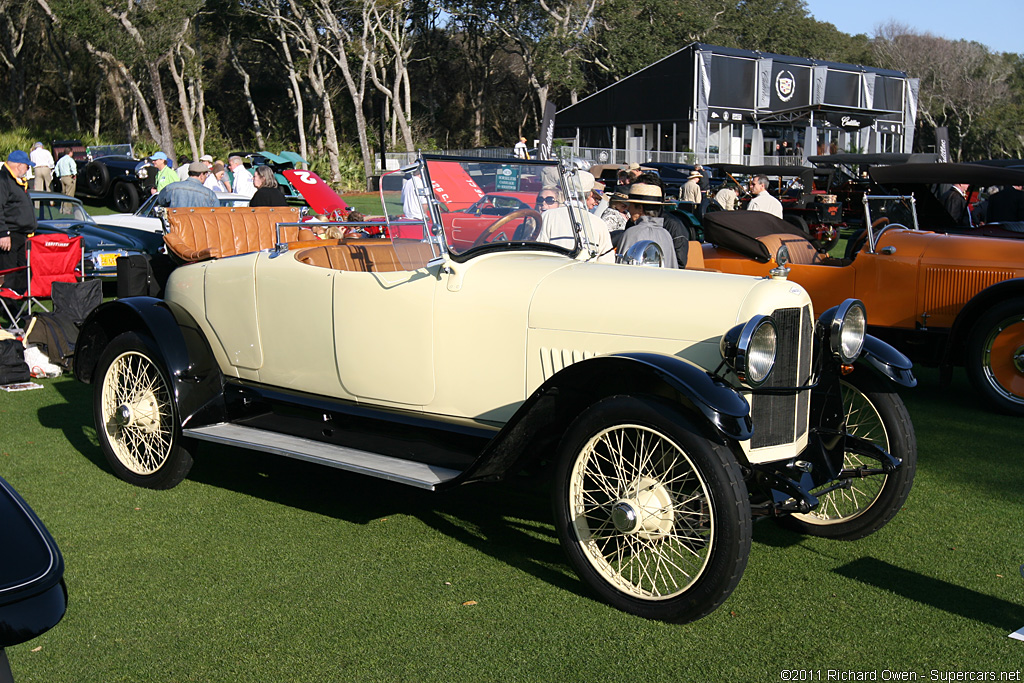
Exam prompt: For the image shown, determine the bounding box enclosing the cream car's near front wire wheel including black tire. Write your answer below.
[555,396,751,622]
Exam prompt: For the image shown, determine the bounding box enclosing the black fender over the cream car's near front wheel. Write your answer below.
[460,353,754,481]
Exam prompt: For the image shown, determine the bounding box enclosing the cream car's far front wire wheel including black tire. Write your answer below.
[780,370,918,541]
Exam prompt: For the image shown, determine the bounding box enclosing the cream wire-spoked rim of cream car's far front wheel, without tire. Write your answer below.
[795,382,890,524]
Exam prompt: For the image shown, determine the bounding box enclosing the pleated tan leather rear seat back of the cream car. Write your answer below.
[164,207,315,261]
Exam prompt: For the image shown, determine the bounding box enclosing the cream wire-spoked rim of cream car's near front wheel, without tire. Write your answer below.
[568,425,715,600]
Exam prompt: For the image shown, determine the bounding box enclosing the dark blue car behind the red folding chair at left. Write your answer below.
[29,191,164,278]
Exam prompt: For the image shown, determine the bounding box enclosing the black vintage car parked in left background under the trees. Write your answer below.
[53,140,157,213]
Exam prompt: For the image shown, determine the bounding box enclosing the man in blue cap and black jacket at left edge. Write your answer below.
[0,150,36,292]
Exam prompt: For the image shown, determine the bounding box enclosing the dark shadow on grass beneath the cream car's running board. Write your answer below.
[188,443,586,595]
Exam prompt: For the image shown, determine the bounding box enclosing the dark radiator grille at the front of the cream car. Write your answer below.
[750,306,814,450]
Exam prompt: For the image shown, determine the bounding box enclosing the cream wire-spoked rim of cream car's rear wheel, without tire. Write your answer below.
[101,351,174,475]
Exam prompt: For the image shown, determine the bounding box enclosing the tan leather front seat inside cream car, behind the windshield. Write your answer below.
[295,240,433,272]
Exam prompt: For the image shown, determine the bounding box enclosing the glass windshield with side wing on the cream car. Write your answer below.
[381,157,586,256]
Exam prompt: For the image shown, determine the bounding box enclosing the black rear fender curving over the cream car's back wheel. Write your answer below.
[75,297,224,425]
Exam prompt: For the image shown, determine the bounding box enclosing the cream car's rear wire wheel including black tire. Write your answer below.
[94,333,191,488]
